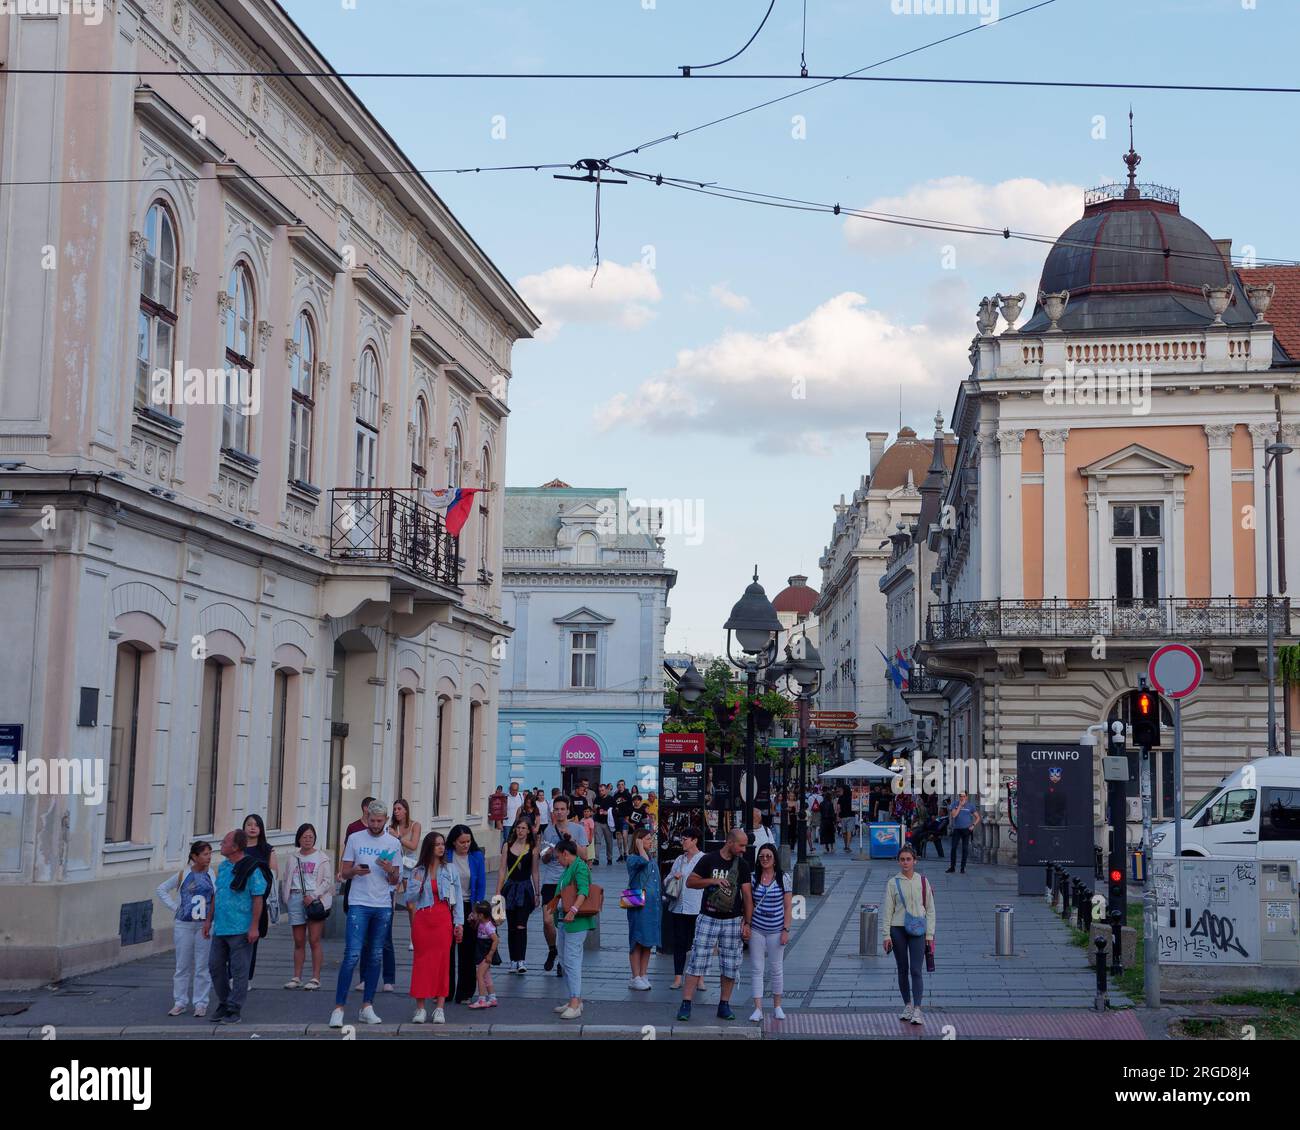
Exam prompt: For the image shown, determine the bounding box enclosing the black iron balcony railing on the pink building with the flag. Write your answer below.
[329,486,460,586]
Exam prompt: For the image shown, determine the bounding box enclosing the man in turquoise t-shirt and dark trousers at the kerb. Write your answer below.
[203,830,268,1025]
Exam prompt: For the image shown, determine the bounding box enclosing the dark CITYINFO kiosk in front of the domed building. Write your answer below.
[1015,741,1096,895]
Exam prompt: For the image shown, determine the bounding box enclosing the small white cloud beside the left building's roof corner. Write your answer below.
[517,260,663,341]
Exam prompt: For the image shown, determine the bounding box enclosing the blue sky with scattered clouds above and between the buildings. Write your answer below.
[282,0,1300,651]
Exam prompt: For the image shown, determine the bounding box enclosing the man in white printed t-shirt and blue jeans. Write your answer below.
[329,801,402,1029]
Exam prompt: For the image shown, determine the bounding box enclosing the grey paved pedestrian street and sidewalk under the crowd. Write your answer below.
[0,853,1128,1039]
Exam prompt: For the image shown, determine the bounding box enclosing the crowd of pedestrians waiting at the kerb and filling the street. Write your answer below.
[165,780,956,1029]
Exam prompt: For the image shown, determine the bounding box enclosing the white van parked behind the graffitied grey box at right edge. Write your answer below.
[1151,757,1300,861]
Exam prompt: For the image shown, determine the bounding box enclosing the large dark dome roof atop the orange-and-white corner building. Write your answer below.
[1021,141,1253,333]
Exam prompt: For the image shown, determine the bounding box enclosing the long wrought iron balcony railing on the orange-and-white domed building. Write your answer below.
[926,597,1291,642]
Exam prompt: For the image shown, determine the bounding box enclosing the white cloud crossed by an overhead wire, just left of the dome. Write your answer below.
[844,177,1083,275]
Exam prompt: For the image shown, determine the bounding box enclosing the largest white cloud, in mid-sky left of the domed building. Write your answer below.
[595,291,970,454]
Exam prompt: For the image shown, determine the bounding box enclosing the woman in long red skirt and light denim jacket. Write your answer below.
[407,832,465,1025]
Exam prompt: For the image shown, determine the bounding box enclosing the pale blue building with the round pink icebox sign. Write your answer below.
[494,480,677,795]
